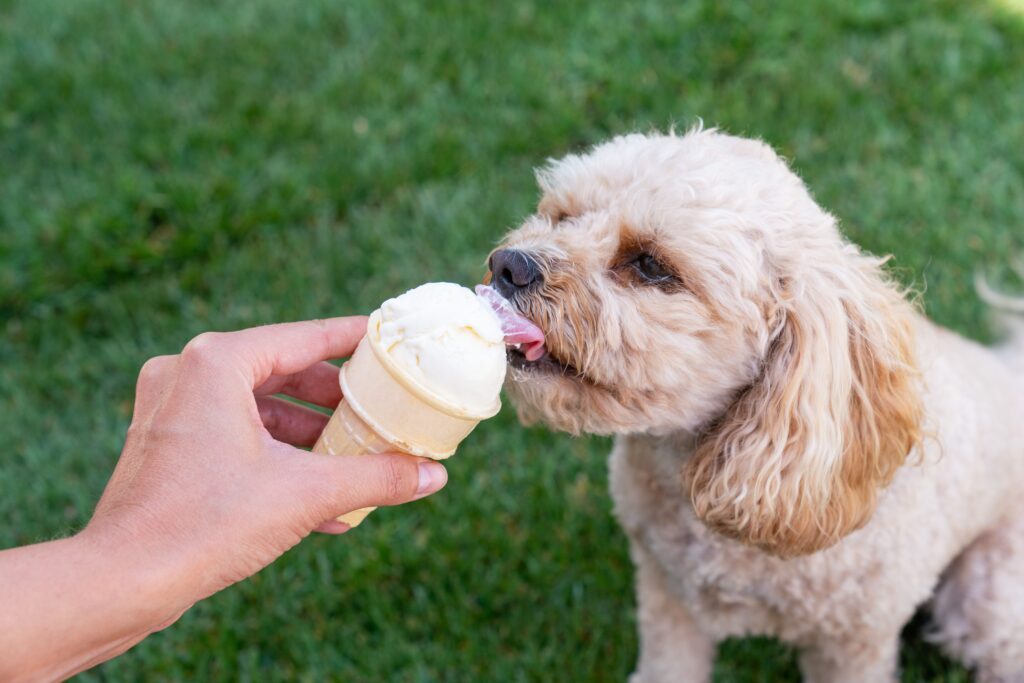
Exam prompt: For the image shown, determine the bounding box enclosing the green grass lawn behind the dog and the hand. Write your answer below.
[0,0,1024,682]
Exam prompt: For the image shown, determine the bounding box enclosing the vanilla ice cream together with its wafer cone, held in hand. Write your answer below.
[313,283,518,527]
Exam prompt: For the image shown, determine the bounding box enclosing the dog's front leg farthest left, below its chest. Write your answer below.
[630,541,715,683]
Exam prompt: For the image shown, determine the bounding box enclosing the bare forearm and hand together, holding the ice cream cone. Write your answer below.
[0,317,447,681]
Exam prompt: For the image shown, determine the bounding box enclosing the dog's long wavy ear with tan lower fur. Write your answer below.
[685,245,922,557]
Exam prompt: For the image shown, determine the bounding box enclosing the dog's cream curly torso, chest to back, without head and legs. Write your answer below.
[609,324,1024,644]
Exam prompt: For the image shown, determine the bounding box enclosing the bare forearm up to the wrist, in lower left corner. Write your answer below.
[0,533,188,681]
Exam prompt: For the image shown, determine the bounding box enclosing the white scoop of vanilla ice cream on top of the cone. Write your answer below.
[378,283,505,411]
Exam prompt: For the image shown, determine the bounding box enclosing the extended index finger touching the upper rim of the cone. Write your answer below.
[181,316,367,389]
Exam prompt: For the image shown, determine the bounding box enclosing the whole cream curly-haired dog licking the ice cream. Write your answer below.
[488,128,1024,683]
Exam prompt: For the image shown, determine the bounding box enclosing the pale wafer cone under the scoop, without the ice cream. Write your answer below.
[313,310,501,526]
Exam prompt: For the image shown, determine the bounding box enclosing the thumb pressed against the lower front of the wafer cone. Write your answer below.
[307,454,447,519]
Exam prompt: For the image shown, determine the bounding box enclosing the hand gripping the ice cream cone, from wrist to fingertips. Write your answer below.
[80,317,447,623]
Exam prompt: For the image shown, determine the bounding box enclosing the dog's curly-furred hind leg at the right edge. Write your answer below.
[932,507,1024,683]
